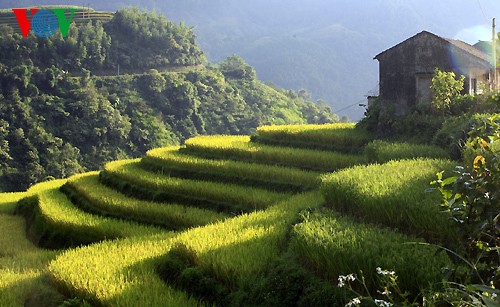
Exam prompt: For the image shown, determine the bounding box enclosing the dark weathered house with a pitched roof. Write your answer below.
[374,31,493,115]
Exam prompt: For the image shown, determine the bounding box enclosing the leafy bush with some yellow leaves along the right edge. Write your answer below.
[433,115,500,289]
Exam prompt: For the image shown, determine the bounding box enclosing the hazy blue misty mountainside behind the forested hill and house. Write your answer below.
[0,0,500,120]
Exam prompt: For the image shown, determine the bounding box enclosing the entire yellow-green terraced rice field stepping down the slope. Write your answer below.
[0,125,453,306]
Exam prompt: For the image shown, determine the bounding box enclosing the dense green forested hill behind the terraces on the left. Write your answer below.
[0,9,338,191]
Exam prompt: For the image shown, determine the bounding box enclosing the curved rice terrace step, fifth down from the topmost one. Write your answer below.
[63,172,228,229]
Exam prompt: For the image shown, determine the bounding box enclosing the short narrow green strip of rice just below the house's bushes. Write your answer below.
[364,140,449,163]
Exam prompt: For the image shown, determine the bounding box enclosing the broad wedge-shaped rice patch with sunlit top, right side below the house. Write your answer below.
[321,159,456,243]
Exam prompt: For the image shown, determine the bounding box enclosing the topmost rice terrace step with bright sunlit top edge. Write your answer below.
[253,124,370,152]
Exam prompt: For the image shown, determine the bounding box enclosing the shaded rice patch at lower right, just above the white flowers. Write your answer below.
[290,212,450,297]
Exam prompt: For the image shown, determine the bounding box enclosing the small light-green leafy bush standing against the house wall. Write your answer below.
[431,68,465,113]
